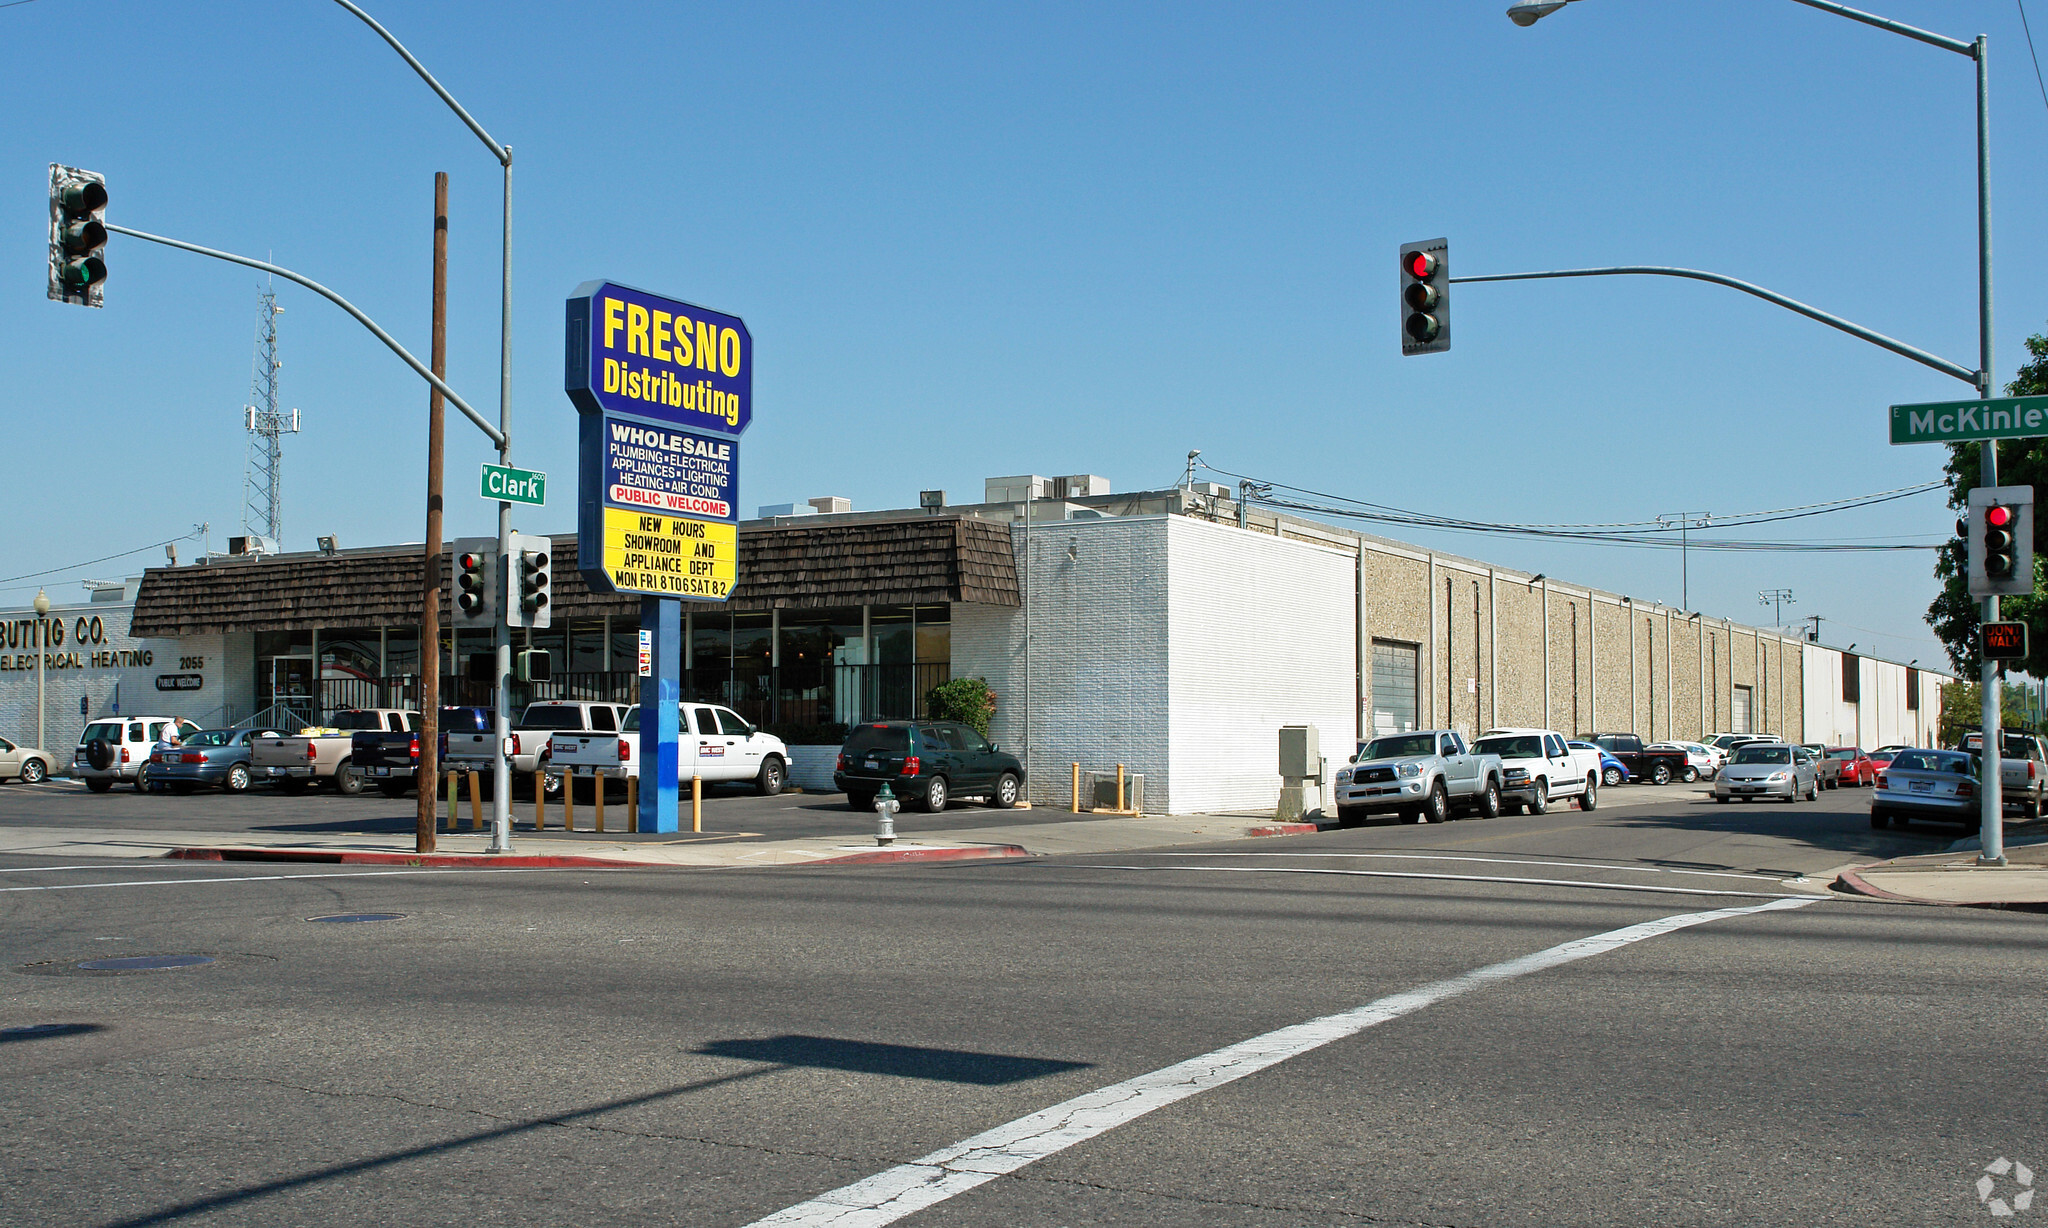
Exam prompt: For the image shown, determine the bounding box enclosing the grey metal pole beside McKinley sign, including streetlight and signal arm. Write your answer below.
[1507,0,2005,866]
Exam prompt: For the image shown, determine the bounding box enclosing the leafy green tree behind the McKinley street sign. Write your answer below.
[1927,321,2048,677]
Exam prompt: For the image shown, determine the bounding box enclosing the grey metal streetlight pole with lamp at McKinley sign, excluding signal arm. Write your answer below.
[1507,0,2005,866]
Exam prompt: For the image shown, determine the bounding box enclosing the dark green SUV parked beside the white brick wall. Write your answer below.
[831,720,1024,815]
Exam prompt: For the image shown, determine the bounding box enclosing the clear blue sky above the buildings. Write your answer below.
[0,0,2048,663]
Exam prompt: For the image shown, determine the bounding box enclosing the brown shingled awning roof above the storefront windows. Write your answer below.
[129,516,1018,637]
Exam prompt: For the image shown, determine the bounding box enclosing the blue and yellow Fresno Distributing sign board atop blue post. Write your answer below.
[565,282,754,602]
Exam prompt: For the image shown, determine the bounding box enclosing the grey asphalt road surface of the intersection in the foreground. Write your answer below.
[0,781,2048,1228]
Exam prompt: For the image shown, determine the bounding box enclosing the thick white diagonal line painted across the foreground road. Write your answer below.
[748,896,1819,1228]
